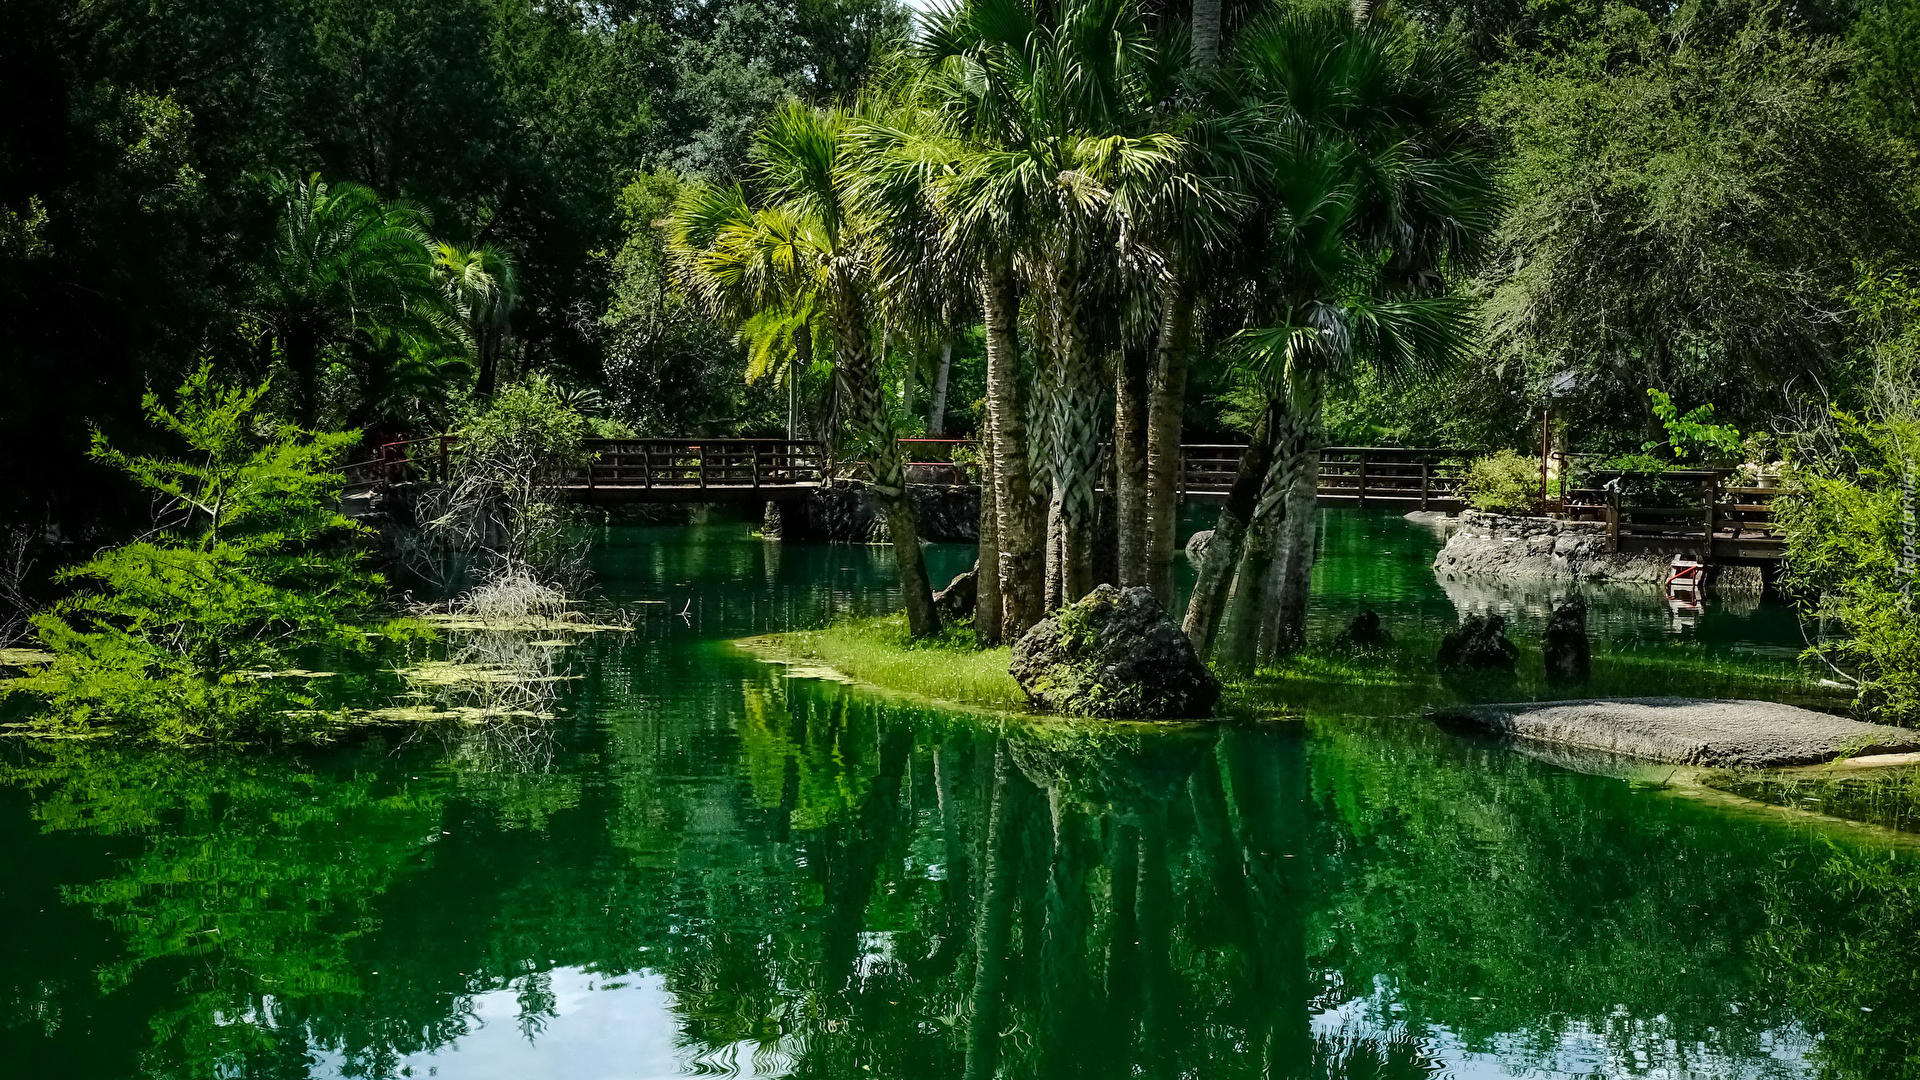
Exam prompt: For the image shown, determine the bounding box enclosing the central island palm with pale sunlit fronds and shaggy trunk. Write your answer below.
[922,0,1179,607]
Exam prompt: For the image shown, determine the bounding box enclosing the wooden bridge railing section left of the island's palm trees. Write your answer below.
[568,438,826,492]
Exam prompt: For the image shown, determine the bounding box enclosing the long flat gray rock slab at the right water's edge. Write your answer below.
[1432,698,1920,769]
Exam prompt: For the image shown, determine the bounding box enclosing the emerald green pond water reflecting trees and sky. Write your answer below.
[0,513,1920,1080]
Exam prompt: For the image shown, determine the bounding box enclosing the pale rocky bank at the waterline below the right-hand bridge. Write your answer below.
[1434,509,1763,592]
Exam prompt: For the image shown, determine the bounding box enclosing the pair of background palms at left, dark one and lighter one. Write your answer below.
[242,175,518,429]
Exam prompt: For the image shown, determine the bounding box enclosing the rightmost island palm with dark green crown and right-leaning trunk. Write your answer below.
[1187,10,1494,663]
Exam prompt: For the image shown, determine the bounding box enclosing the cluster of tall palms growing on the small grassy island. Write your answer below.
[670,0,1494,663]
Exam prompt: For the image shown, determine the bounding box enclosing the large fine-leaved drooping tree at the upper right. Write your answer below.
[1480,0,1908,442]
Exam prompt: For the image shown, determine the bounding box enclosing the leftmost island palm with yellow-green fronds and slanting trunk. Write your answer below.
[670,104,939,638]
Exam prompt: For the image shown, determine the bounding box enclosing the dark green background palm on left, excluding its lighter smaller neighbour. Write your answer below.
[242,173,440,427]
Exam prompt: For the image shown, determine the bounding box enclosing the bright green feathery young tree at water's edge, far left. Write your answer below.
[4,367,412,742]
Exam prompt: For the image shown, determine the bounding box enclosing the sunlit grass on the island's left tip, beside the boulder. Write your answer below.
[739,615,1027,711]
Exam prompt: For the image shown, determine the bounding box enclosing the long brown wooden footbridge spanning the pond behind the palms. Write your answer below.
[348,436,1786,563]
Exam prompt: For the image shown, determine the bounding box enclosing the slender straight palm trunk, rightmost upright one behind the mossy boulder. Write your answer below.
[1146,270,1194,607]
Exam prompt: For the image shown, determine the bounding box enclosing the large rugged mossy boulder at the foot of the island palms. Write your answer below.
[1010,584,1219,721]
